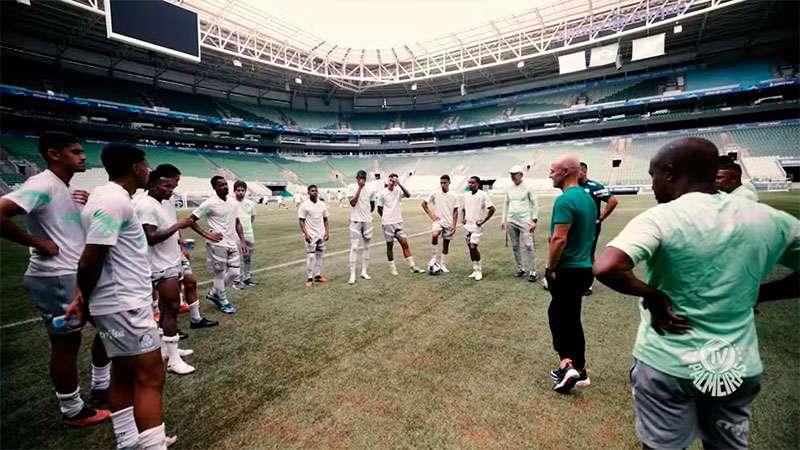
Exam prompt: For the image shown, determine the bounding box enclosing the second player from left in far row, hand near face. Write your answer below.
[347,170,376,284]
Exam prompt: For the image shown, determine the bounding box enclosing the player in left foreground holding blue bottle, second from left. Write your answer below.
[67,144,167,449]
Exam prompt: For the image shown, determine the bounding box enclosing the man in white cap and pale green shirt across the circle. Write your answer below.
[500,166,539,282]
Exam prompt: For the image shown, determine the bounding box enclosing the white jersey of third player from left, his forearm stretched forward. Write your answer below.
[133,195,183,272]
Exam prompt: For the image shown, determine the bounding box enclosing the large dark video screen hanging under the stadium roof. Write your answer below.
[105,0,200,62]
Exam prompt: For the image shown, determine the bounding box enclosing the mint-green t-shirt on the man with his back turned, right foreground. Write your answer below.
[608,192,800,385]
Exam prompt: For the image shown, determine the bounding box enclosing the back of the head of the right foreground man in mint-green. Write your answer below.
[650,137,719,203]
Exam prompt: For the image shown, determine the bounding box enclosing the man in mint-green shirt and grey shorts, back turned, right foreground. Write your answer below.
[594,138,800,448]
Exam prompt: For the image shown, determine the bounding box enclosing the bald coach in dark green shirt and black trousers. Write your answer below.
[545,155,597,393]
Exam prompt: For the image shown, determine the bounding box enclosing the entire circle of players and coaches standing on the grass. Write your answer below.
[0,133,800,449]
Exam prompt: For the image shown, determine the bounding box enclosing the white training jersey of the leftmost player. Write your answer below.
[3,170,86,277]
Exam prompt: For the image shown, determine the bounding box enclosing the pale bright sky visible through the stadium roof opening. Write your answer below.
[242,0,536,49]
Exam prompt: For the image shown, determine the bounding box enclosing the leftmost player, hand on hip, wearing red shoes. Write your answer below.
[0,132,111,426]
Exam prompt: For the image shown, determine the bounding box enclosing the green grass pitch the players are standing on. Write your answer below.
[0,193,800,449]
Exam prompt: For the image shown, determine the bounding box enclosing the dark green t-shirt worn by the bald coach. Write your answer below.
[550,186,597,269]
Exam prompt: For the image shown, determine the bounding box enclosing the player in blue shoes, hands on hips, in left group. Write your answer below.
[191,175,250,314]
